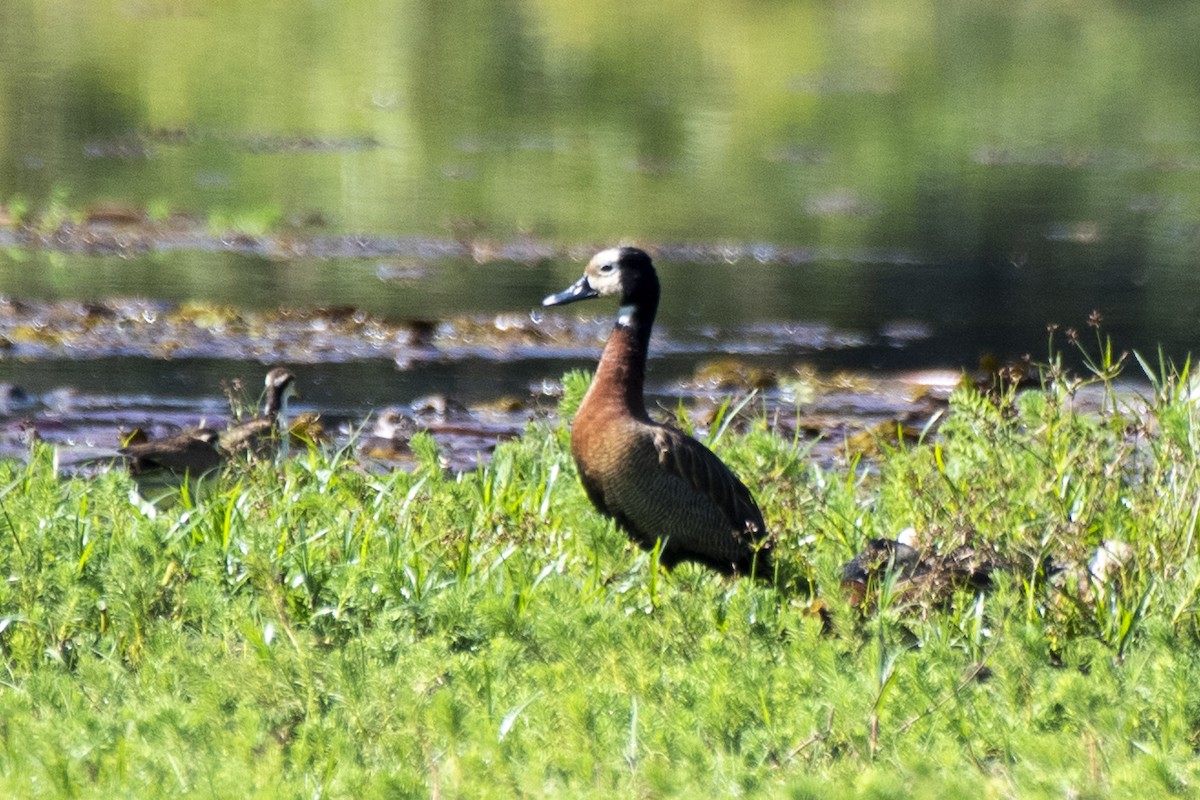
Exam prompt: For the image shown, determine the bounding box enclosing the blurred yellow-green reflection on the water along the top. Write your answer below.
[0,0,1200,264]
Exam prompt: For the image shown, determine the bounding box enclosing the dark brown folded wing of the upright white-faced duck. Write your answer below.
[654,426,767,541]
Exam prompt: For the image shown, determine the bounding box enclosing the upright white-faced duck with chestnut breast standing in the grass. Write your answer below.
[542,246,773,578]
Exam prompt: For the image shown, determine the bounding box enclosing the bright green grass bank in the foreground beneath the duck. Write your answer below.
[0,362,1200,799]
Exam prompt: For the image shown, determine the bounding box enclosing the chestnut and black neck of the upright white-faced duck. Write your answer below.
[588,287,659,420]
